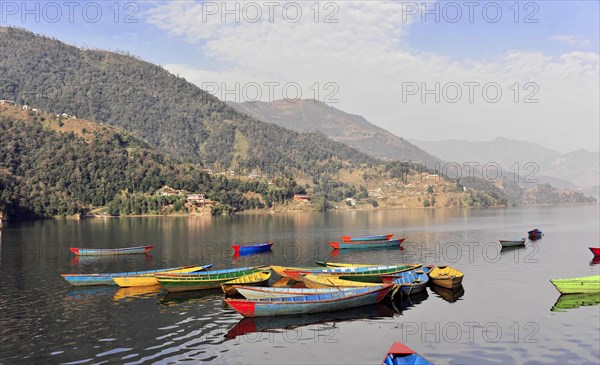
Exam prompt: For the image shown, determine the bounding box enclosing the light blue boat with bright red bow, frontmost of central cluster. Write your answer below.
[225,284,392,317]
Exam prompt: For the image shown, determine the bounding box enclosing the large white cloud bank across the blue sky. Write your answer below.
[147,1,600,151]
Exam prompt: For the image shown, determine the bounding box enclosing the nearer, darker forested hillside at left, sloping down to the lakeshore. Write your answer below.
[0,105,304,219]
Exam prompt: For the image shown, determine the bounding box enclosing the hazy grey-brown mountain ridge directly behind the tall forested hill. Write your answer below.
[228,99,441,168]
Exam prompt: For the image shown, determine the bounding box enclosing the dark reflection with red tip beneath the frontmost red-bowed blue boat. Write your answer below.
[225,303,394,339]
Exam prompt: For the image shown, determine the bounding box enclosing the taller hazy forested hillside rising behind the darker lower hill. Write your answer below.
[0,28,375,175]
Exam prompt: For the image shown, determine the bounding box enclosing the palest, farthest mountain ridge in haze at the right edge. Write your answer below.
[411,137,600,188]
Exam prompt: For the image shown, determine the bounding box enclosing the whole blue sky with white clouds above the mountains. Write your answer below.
[0,0,600,153]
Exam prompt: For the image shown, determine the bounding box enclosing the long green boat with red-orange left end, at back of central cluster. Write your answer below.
[284,264,422,283]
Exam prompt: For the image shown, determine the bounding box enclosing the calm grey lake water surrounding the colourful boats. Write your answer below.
[0,205,600,364]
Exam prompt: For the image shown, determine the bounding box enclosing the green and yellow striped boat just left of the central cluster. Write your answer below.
[156,266,269,292]
